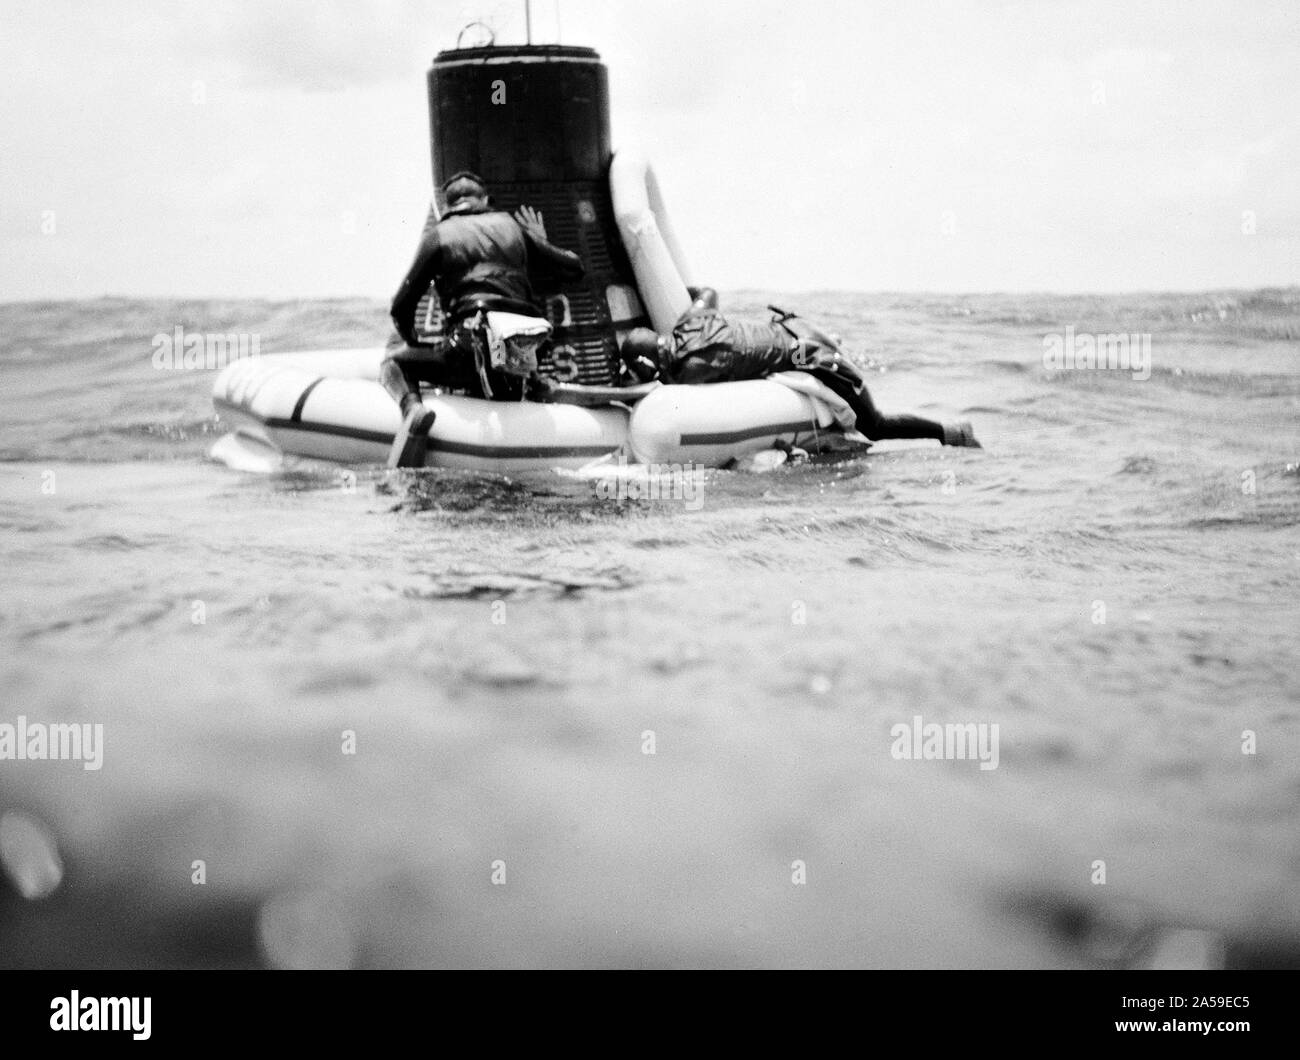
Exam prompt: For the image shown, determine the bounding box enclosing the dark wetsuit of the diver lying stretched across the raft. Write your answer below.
[660,287,944,442]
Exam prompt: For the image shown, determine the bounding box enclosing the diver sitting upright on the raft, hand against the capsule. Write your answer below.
[380,173,584,467]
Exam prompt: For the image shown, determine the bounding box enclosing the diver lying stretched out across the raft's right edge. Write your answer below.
[621,287,983,449]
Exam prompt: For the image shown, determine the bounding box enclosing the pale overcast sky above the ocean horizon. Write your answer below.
[0,0,1300,299]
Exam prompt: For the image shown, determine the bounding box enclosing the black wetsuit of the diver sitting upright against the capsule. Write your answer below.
[380,200,584,403]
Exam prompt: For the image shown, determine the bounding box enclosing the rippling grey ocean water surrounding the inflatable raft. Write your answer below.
[0,289,1300,968]
